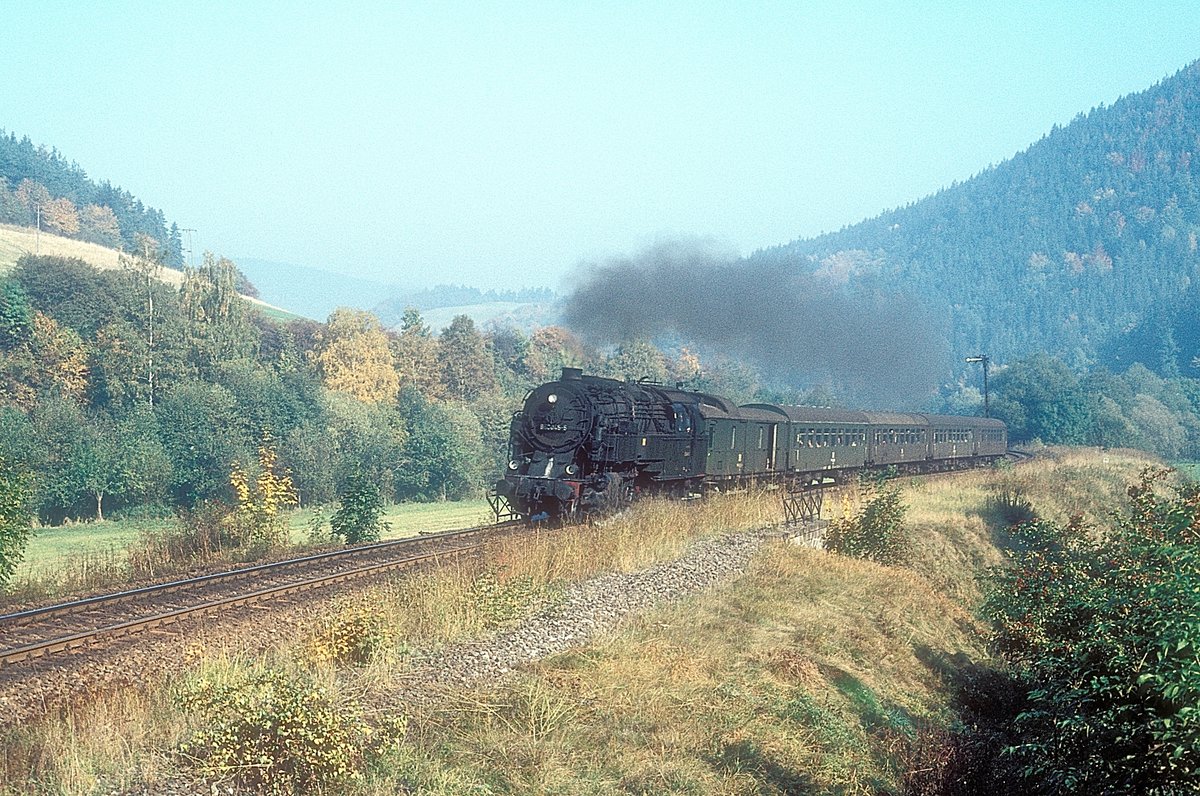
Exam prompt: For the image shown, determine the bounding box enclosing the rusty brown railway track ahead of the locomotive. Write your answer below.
[0,522,524,672]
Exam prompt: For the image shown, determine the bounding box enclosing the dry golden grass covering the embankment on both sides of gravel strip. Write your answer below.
[0,450,1152,794]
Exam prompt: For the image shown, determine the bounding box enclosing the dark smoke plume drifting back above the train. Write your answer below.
[564,244,949,409]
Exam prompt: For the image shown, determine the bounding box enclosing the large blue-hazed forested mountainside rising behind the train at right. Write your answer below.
[750,61,1200,376]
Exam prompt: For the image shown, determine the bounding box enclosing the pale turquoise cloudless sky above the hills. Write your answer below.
[0,0,1200,291]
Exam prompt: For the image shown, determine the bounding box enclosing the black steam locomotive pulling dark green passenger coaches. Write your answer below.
[494,367,1008,519]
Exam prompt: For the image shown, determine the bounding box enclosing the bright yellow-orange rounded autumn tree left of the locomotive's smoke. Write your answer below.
[317,307,400,403]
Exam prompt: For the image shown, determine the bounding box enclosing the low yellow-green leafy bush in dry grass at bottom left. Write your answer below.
[180,669,391,794]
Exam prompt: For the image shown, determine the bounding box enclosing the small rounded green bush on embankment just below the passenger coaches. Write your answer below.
[824,478,910,564]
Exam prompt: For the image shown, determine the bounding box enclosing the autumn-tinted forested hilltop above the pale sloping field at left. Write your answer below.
[0,130,184,268]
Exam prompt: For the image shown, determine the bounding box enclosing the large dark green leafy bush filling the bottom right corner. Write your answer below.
[986,471,1200,795]
